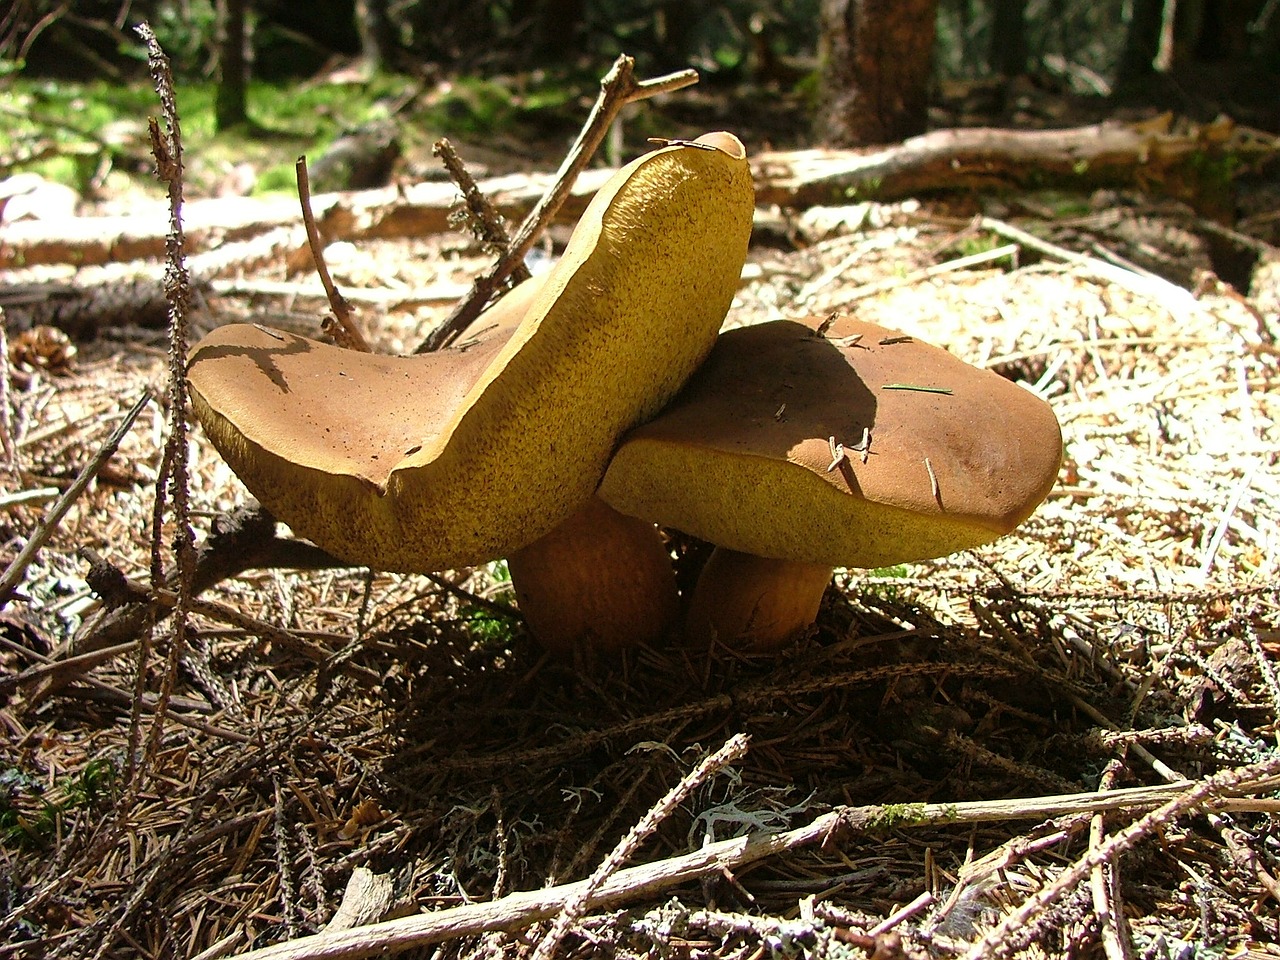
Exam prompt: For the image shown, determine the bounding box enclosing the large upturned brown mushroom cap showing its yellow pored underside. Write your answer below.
[188,133,754,571]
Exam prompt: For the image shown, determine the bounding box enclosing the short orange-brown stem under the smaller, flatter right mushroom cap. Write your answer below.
[685,547,835,652]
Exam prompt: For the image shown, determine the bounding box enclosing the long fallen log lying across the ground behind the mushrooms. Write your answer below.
[0,115,1277,305]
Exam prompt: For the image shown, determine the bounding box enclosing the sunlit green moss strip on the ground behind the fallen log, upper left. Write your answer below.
[0,68,582,195]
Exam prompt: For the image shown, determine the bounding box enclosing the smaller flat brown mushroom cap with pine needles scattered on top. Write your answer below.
[599,317,1062,567]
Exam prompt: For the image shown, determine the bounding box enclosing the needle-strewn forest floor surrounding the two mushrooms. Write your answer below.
[0,73,1280,960]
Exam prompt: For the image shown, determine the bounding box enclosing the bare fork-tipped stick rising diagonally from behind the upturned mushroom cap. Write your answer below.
[416,54,698,353]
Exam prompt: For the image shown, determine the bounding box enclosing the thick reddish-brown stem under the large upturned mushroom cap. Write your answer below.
[507,497,680,655]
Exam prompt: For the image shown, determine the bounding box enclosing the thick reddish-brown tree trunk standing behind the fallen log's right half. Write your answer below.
[818,0,937,146]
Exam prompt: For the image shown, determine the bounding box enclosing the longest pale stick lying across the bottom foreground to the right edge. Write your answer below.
[230,763,1280,960]
